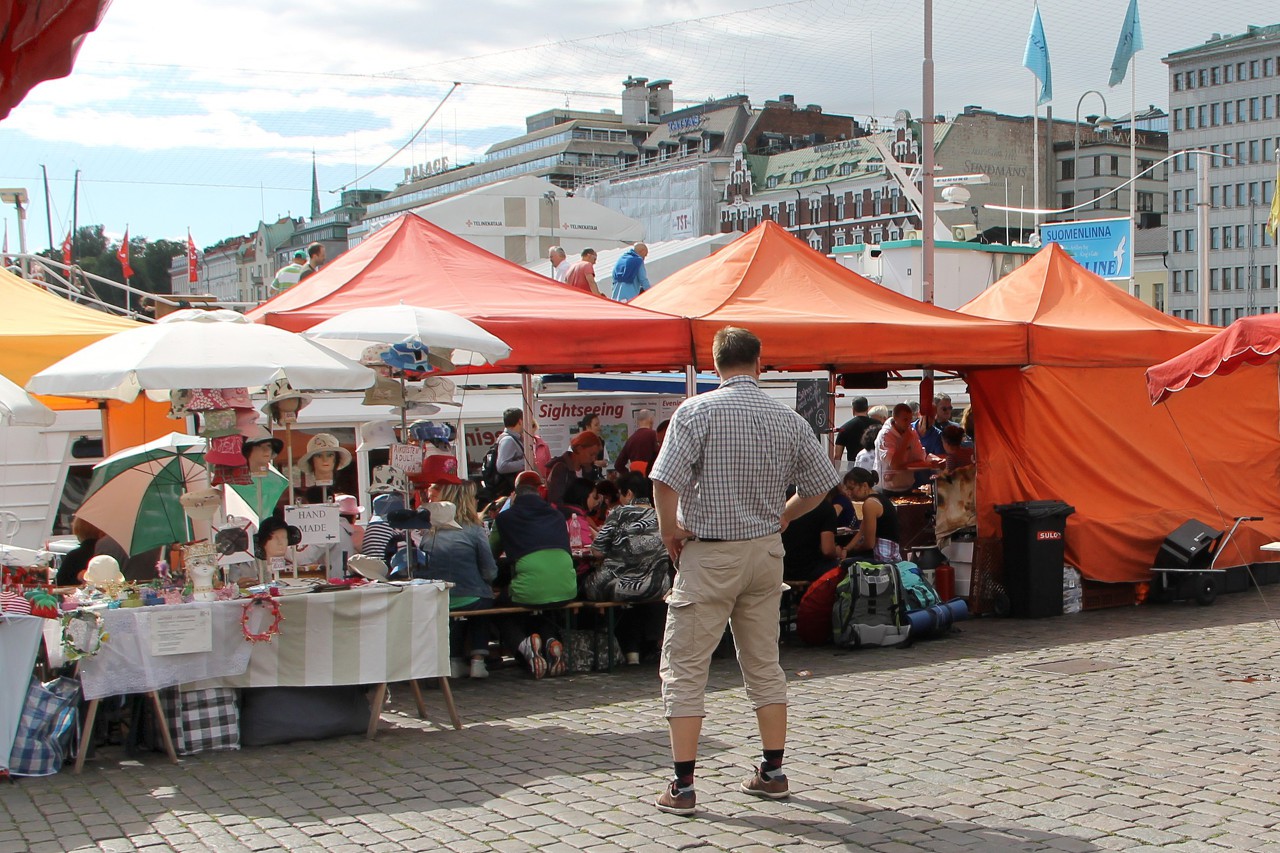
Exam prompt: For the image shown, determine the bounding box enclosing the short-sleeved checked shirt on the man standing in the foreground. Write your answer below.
[652,374,840,539]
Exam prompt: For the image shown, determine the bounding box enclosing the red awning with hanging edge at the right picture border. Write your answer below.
[1147,314,1280,403]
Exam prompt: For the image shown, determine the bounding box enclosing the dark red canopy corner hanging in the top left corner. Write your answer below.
[0,0,111,119]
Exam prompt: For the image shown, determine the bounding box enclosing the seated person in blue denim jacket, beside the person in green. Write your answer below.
[413,499,498,679]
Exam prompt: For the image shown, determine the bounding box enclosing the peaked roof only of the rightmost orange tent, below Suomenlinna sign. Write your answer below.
[959,243,1216,368]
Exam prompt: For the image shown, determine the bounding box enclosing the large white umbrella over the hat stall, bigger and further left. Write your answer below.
[27,309,374,402]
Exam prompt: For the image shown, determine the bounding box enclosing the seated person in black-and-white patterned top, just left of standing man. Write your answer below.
[582,471,672,665]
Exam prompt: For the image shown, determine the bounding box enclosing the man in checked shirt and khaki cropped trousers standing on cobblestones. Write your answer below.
[653,327,838,815]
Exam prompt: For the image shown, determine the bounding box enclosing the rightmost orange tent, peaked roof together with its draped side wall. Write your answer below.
[960,245,1280,583]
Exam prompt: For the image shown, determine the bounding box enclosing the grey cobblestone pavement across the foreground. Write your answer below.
[0,587,1280,853]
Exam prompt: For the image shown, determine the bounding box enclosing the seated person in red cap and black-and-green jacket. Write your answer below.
[489,471,577,679]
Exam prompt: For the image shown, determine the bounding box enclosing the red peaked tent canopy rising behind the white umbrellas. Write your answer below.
[248,214,690,373]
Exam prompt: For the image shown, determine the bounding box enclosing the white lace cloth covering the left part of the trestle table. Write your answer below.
[81,601,253,699]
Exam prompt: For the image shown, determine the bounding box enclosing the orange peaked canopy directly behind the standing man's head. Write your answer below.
[631,222,1027,370]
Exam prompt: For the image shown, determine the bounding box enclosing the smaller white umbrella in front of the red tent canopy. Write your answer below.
[302,304,511,365]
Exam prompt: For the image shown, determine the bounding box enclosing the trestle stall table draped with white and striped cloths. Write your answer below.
[76,583,462,772]
